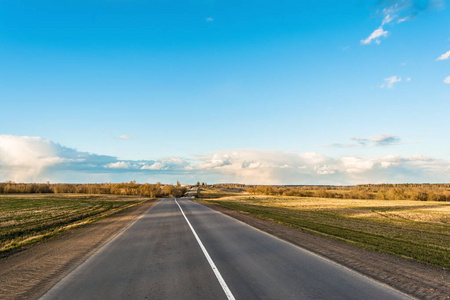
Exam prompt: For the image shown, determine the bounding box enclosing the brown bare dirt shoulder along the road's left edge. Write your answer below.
[0,200,158,300]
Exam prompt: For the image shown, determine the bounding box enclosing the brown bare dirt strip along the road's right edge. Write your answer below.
[199,201,450,299]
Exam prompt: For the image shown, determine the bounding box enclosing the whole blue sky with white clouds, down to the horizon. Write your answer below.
[0,0,450,185]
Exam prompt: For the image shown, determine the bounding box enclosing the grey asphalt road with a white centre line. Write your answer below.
[42,192,409,300]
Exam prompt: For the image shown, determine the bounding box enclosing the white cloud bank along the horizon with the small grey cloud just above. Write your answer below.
[0,135,450,184]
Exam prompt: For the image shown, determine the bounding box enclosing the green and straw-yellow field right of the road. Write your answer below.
[201,188,450,269]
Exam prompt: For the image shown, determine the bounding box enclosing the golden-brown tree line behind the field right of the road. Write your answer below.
[246,184,450,201]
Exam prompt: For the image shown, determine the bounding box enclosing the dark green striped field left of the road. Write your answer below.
[0,194,149,256]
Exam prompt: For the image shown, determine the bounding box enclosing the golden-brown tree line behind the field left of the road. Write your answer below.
[0,181,187,198]
